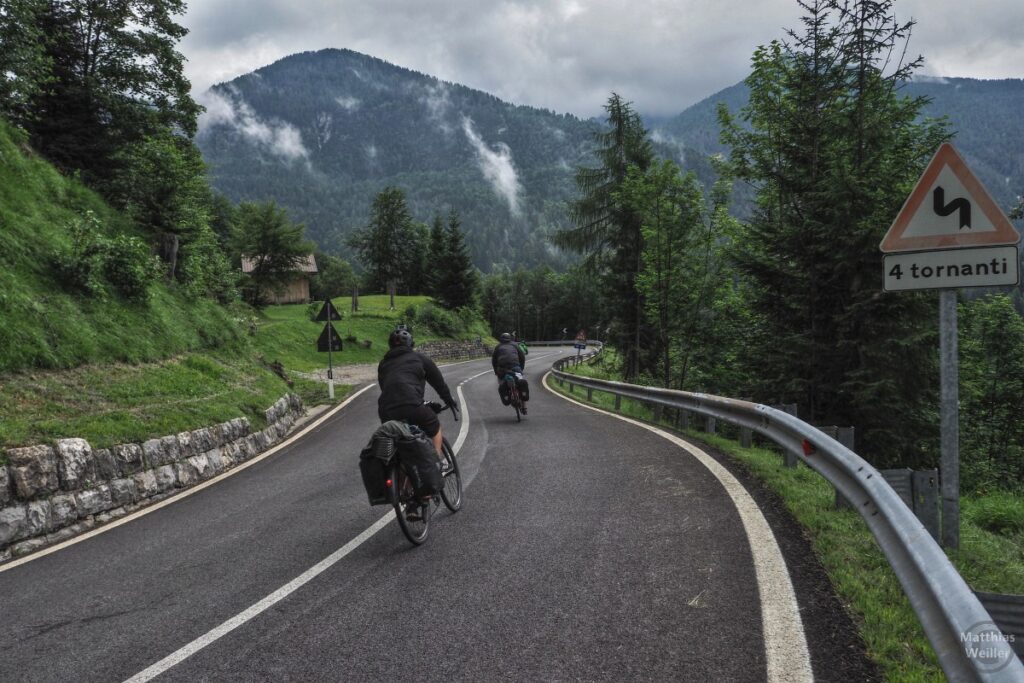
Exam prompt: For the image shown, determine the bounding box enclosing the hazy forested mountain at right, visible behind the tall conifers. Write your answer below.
[652,77,1024,211]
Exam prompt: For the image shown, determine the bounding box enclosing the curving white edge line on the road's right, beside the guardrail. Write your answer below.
[542,372,814,682]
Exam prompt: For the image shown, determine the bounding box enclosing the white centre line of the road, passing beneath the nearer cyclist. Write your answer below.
[119,370,490,683]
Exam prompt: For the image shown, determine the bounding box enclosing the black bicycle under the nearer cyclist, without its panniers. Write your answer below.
[386,402,462,546]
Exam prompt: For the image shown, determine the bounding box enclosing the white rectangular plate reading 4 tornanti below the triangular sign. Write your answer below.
[885,247,1020,292]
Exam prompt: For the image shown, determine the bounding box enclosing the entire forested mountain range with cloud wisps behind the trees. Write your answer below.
[197,49,1024,271]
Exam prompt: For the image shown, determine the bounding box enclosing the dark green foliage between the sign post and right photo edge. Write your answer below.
[958,294,1024,490]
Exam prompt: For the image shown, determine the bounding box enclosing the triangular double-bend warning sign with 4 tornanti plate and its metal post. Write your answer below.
[879,142,1020,548]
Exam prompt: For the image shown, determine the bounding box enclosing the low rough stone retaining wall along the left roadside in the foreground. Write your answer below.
[0,394,302,562]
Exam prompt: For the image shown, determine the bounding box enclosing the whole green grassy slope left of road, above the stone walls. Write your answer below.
[0,121,485,454]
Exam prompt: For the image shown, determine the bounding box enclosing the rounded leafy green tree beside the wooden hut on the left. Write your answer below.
[233,202,313,306]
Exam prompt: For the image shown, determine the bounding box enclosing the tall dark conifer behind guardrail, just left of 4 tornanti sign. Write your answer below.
[722,0,946,466]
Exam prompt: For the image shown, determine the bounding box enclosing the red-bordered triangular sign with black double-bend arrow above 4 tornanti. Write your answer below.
[879,142,1021,253]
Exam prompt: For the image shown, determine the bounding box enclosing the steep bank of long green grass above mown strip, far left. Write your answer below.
[0,121,242,374]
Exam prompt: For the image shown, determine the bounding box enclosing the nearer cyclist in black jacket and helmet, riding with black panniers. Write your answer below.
[377,328,459,460]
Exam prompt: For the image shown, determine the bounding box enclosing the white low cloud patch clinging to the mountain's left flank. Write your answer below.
[198,90,309,162]
